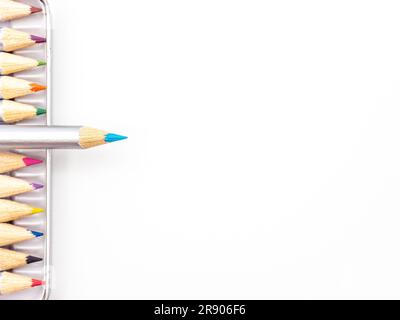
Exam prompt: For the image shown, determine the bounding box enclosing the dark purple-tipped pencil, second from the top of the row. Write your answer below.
[0,28,46,52]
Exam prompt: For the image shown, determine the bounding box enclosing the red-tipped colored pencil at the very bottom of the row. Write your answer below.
[0,272,44,296]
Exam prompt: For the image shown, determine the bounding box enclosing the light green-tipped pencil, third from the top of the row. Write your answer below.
[0,52,46,75]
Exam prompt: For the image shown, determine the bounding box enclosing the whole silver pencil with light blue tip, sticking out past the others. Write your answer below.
[0,126,127,149]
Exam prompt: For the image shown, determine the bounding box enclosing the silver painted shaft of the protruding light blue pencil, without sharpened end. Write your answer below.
[0,126,81,149]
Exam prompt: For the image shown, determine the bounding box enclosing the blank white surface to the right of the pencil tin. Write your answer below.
[50,0,400,299]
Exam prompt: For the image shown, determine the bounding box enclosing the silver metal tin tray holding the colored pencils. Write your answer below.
[0,0,51,300]
